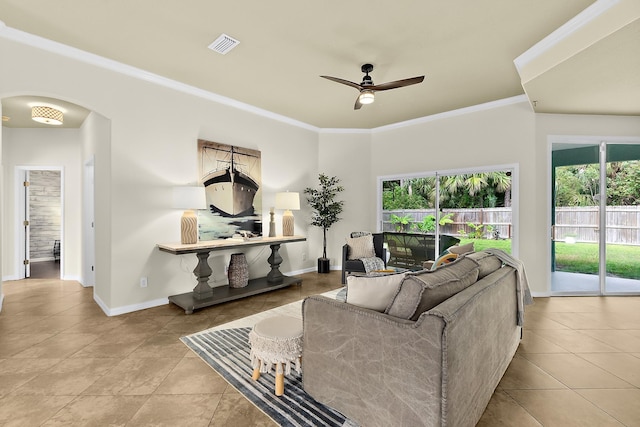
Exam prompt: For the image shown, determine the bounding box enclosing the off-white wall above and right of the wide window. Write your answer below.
[372,102,545,291]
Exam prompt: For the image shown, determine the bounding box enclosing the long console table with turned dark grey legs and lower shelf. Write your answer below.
[157,236,307,314]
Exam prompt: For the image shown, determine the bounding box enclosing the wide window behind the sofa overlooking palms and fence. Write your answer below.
[379,167,516,270]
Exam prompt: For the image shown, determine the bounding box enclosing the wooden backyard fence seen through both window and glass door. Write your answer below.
[382,206,640,245]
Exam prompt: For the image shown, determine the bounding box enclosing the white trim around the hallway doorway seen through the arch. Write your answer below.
[14,166,66,279]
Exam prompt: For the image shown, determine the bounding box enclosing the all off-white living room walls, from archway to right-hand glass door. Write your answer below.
[0,34,640,314]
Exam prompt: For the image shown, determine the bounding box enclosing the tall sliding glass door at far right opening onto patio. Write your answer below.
[551,142,640,295]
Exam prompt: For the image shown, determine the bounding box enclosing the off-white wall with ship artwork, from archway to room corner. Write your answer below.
[0,39,318,313]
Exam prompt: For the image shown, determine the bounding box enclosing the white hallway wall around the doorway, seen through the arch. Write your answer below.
[2,127,81,280]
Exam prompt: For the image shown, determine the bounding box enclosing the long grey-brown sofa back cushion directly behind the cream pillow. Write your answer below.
[385,257,479,320]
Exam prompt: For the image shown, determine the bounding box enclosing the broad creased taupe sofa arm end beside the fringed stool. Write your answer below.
[302,295,444,426]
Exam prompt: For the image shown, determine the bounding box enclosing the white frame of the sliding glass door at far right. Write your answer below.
[545,135,640,296]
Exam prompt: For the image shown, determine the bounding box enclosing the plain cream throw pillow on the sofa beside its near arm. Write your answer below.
[347,273,406,312]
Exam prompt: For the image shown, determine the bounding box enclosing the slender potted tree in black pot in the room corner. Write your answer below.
[304,173,344,273]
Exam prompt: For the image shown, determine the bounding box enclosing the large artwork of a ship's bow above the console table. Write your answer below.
[198,139,262,240]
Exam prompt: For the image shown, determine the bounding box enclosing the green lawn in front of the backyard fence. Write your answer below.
[460,239,640,279]
